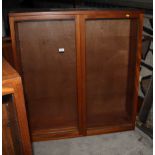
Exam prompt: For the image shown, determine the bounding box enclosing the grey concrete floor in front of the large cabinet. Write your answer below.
[33,128,153,155]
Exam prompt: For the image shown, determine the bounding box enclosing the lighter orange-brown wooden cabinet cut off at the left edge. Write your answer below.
[2,59,32,155]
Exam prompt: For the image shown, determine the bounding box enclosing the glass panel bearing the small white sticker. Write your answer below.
[16,19,78,138]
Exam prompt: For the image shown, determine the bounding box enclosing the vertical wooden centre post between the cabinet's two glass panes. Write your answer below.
[76,15,86,135]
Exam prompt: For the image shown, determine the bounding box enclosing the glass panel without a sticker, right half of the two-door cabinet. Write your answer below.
[86,19,137,131]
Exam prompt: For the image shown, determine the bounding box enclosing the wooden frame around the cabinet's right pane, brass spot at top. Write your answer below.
[81,12,143,135]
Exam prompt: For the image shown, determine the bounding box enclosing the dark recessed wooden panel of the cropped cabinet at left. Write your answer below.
[2,94,23,155]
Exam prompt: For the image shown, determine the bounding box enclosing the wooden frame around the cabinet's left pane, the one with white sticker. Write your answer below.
[10,15,82,141]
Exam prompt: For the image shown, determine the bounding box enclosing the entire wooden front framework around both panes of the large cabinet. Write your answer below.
[9,10,143,141]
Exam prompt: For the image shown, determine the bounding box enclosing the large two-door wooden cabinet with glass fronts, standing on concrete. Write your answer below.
[10,10,143,141]
